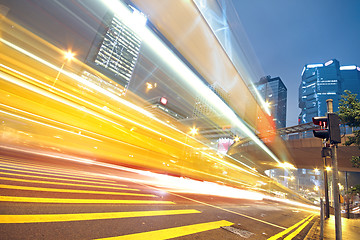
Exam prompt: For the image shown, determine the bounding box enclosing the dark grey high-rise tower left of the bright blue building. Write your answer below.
[255,76,287,128]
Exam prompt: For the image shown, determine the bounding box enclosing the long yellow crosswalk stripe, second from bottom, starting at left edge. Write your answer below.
[0,209,201,223]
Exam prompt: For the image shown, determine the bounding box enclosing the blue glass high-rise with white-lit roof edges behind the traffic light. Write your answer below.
[298,59,360,124]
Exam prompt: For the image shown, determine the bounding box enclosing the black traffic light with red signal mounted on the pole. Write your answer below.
[313,113,341,144]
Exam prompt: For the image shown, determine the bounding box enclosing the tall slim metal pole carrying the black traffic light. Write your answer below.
[326,99,342,240]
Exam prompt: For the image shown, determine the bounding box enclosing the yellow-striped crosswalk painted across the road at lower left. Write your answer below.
[0,157,233,239]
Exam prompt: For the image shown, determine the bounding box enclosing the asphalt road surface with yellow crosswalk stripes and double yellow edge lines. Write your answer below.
[0,151,317,240]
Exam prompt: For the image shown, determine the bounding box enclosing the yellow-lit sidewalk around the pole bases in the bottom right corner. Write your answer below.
[305,215,360,240]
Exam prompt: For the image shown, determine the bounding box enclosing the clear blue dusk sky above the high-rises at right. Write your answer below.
[231,0,360,126]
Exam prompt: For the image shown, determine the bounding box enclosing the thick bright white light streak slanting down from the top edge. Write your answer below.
[103,0,281,163]
